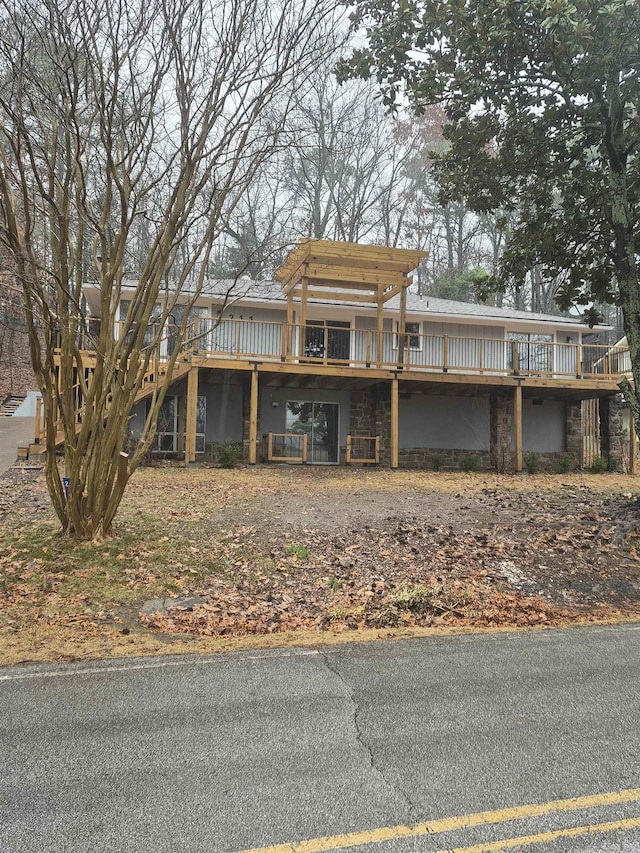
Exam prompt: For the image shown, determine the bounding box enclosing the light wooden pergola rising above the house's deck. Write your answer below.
[275,238,428,361]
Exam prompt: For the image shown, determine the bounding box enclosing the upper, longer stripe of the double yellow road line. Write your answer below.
[232,788,640,853]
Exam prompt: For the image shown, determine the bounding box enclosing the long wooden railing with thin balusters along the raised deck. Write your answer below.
[62,318,631,379]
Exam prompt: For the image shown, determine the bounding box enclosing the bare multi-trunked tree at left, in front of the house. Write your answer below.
[0,0,341,540]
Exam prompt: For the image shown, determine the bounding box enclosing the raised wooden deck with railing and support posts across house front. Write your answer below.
[47,319,628,470]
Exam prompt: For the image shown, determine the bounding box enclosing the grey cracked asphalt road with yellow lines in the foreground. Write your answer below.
[0,626,640,853]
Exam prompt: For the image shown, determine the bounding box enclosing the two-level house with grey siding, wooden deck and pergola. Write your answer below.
[65,240,623,471]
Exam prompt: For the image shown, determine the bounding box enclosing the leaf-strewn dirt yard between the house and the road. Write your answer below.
[0,467,640,662]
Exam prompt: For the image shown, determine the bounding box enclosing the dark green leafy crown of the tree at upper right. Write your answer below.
[343,0,640,313]
